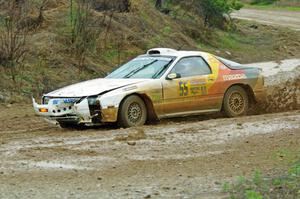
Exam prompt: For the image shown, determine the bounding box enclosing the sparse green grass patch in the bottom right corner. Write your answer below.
[223,149,300,199]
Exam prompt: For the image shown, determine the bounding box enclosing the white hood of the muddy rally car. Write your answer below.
[45,78,149,97]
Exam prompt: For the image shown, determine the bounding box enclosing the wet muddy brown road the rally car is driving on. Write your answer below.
[0,59,300,199]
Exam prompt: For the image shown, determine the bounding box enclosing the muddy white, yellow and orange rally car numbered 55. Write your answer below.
[33,48,264,128]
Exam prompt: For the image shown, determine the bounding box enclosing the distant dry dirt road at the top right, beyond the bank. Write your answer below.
[231,9,300,31]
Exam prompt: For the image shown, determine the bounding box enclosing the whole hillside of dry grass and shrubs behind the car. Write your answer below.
[0,0,300,103]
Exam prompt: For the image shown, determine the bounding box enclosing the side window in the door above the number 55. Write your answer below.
[171,57,211,77]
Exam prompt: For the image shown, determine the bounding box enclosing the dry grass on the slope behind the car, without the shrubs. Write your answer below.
[0,0,300,102]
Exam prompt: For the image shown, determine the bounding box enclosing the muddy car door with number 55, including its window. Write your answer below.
[162,56,214,116]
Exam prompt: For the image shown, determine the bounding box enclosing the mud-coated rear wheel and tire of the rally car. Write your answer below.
[223,86,249,117]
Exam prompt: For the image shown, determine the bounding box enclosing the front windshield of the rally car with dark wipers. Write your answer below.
[106,56,174,79]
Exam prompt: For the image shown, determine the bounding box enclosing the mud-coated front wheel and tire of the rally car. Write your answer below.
[118,95,147,128]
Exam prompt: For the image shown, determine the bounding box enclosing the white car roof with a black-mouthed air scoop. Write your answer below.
[146,48,209,57]
